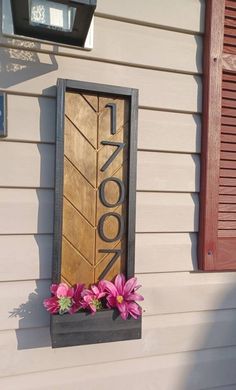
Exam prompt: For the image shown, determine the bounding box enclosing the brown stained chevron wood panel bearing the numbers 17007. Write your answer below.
[61,92,130,286]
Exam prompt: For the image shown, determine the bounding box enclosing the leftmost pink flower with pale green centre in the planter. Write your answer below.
[43,283,74,314]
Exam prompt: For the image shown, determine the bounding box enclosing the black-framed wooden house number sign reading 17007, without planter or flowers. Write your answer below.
[53,80,137,286]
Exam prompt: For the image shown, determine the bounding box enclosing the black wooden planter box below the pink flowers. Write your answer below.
[51,309,142,348]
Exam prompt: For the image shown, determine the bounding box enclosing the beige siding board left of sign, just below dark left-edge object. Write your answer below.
[0,142,55,188]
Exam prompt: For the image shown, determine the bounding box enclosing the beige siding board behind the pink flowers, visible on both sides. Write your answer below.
[0,272,236,330]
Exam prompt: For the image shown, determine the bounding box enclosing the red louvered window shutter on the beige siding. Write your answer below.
[199,0,236,271]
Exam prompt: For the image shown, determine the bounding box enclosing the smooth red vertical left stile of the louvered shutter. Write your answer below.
[198,0,225,271]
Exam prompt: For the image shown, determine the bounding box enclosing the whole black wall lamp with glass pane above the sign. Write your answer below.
[11,0,97,47]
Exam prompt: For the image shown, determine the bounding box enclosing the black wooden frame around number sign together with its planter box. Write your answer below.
[51,79,141,348]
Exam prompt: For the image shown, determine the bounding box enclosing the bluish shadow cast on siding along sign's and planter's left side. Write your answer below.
[9,90,56,350]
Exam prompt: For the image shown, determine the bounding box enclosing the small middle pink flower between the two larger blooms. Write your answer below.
[82,281,106,314]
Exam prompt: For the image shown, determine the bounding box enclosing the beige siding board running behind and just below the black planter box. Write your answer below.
[0,309,236,376]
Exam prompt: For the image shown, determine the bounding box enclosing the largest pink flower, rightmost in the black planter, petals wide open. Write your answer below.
[101,274,144,320]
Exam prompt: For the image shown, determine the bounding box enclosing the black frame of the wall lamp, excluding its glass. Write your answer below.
[11,0,97,47]
